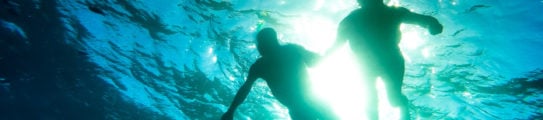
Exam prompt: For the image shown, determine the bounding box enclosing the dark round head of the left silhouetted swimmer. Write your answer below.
[256,28,279,56]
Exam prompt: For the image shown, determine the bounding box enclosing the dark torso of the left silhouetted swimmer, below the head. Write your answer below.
[250,45,307,107]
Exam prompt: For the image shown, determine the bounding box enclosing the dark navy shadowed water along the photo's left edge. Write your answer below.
[0,0,166,120]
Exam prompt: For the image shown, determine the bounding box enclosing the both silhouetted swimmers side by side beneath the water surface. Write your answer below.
[222,0,443,120]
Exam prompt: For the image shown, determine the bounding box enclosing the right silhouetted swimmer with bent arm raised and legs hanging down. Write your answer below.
[328,0,443,119]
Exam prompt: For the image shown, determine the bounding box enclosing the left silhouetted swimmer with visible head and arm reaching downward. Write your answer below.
[222,28,334,120]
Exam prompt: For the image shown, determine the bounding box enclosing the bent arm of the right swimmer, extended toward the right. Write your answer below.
[402,8,443,35]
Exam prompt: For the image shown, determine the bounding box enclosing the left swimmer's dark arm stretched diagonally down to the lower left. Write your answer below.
[221,65,258,120]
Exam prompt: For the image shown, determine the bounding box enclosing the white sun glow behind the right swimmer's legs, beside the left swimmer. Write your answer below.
[308,44,399,120]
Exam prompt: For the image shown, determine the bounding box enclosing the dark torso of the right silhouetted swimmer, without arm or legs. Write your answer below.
[339,7,408,69]
